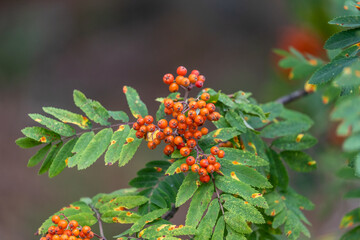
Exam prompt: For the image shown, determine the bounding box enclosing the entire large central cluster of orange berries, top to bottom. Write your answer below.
[133,66,225,182]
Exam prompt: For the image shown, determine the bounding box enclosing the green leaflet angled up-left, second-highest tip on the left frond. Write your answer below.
[73,90,110,126]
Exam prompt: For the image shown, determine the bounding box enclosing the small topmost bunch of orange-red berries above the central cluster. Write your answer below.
[163,66,205,92]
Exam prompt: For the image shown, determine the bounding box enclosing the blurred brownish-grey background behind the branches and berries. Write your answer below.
[0,0,358,240]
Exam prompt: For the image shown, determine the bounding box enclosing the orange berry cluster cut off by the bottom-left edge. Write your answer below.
[40,215,95,240]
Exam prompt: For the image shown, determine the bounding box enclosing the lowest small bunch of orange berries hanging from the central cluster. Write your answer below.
[180,146,225,183]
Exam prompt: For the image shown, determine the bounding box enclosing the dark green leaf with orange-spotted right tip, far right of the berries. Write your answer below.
[280,151,316,172]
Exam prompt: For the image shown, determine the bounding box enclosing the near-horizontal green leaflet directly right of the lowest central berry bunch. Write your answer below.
[215,148,269,167]
